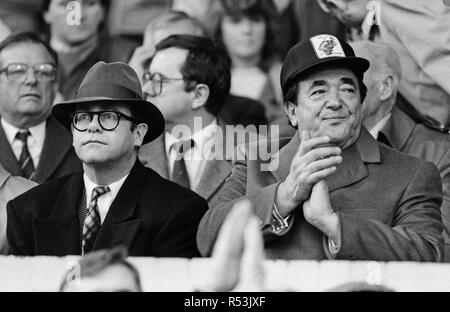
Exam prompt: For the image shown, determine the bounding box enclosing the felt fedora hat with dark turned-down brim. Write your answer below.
[52,62,165,144]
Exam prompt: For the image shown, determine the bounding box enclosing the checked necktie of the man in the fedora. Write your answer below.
[81,186,110,254]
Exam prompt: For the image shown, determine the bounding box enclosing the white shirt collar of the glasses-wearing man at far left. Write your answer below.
[1,118,47,168]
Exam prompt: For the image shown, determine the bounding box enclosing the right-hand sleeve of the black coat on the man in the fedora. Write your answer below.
[154,193,208,258]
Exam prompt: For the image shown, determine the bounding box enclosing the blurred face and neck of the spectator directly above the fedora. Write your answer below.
[43,0,106,100]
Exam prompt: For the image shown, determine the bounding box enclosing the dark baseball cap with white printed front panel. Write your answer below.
[280,34,370,93]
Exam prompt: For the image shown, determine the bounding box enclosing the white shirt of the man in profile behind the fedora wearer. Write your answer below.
[165,120,219,191]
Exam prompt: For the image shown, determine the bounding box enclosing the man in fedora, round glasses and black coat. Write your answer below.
[7,62,208,257]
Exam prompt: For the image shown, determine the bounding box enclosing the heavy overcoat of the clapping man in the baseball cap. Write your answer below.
[197,128,443,261]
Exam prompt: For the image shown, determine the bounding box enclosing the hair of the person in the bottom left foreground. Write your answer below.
[59,246,142,291]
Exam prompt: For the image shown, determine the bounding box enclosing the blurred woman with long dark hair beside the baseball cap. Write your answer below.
[216,0,288,124]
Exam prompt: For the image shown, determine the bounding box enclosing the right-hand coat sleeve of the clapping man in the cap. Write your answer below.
[336,162,443,262]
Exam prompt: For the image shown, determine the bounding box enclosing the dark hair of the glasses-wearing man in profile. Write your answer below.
[156,35,231,116]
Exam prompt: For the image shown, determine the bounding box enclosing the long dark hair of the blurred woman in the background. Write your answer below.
[215,0,276,72]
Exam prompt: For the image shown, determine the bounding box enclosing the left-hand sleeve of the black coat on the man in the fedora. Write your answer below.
[6,200,33,256]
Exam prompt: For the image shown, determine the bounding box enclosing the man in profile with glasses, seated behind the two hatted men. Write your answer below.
[139,35,262,207]
